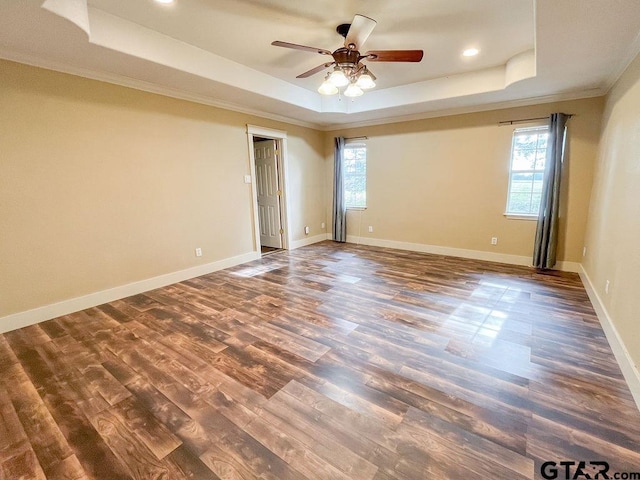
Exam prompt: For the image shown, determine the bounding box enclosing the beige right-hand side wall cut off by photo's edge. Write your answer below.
[583,52,640,369]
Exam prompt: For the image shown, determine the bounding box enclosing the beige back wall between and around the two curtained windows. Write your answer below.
[326,98,603,262]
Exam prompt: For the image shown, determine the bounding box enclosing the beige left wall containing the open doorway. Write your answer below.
[0,61,326,320]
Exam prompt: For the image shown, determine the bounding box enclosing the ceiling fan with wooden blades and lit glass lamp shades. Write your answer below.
[271,15,424,97]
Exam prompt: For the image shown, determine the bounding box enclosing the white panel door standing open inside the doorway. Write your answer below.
[253,140,282,248]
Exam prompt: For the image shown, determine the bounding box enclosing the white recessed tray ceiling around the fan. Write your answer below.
[0,0,640,129]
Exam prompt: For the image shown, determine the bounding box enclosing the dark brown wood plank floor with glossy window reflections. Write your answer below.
[0,242,640,480]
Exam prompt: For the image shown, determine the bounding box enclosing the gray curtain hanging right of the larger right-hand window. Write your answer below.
[533,113,569,269]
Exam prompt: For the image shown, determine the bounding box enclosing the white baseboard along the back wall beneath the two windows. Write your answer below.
[347,235,580,273]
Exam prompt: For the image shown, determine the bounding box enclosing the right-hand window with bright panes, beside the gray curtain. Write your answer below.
[506,127,549,216]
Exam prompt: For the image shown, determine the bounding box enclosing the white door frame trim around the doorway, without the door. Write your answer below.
[247,124,291,253]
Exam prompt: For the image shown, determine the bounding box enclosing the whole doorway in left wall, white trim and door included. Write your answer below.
[247,126,289,256]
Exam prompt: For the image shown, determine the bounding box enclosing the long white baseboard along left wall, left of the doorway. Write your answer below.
[0,252,260,333]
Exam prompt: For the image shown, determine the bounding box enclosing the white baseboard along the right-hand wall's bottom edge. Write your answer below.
[580,265,640,410]
